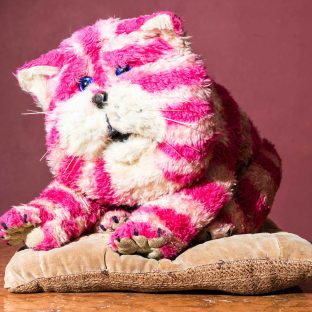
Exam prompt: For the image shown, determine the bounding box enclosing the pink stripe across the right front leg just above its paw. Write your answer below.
[139,206,196,243]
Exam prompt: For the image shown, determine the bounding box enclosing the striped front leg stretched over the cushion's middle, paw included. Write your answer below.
[110,181,231,259]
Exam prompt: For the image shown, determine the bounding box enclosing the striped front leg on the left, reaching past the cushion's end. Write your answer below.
[0,181,102,250]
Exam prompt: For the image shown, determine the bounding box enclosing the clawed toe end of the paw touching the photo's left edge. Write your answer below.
[0,206,41,245]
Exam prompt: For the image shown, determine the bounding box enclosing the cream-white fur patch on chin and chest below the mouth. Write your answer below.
[103,136,180,205]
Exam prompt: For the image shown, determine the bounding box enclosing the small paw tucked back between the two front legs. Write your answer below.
[96,209,130,233]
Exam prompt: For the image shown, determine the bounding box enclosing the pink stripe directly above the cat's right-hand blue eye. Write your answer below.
[104,38,172,67]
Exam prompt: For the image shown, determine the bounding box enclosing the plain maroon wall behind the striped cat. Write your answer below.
[0,0,312,240]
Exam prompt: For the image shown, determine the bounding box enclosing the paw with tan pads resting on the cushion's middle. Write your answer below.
[110,222,170,259]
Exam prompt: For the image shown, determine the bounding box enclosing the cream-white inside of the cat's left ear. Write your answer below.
[16,65,59,110]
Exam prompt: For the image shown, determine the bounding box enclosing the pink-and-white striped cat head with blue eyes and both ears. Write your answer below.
[17,12,213,185]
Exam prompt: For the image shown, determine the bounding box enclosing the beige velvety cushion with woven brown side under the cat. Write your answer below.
[5,222,312,294]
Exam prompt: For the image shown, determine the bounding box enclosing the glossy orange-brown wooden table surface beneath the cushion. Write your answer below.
[0,246,312,312]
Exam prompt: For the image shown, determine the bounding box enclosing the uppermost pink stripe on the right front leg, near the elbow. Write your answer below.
[183,181,231,215]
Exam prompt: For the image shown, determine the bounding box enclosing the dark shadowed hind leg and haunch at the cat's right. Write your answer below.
[194,140,281,243]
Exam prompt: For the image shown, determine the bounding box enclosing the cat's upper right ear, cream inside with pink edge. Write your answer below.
[141,12,183,36]
